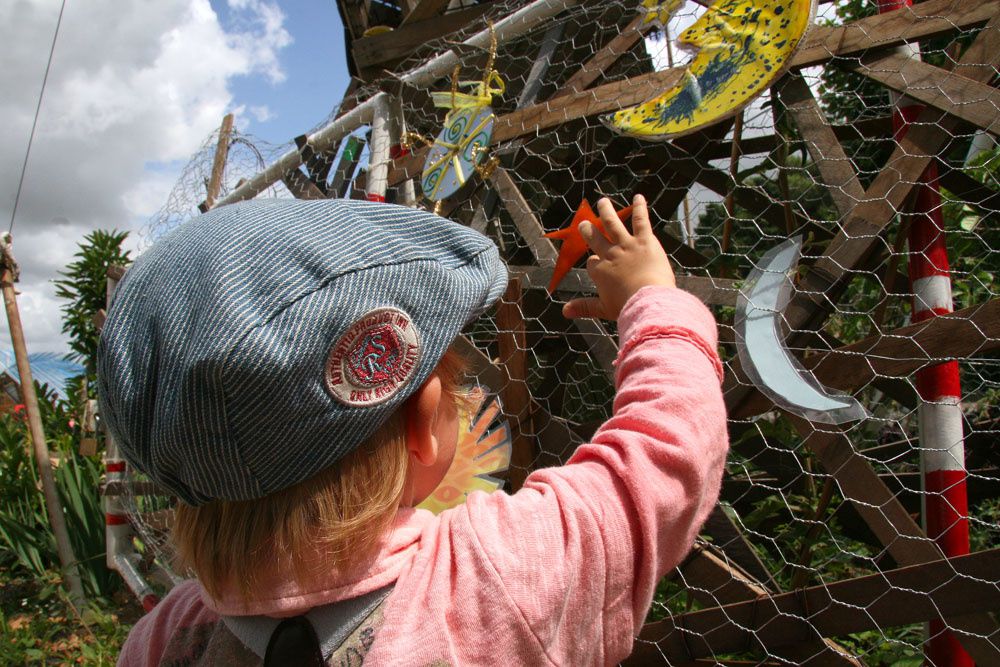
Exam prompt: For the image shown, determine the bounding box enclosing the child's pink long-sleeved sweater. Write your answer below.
[119,287,728,665]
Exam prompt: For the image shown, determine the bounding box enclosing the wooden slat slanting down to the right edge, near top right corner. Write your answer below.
[844,53,1000,137]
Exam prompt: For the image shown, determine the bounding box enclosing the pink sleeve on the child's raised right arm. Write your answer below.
[456,287,728,664]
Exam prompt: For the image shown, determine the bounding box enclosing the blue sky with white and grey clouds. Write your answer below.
[0,0,348,353]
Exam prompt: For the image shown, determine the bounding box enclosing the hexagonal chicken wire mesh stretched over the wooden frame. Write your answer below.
[103,0,1000,665]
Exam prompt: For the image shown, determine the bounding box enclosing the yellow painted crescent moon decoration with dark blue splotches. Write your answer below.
[601,0,816,141]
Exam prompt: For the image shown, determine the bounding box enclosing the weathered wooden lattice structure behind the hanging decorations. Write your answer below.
[109,0,1000,665]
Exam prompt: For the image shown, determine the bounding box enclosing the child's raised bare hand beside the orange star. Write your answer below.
[563,195,676,320]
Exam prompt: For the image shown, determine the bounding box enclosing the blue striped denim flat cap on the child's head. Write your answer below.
[98,200,507,505]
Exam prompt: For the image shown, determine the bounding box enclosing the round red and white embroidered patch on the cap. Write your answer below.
[326,308,420,406]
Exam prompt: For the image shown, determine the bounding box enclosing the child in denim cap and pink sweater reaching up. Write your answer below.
[99,195,727,666]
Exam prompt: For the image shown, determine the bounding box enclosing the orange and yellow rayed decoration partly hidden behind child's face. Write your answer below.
[417,387,513,514]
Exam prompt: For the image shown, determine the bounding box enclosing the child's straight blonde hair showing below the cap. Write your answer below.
[172,346,468,598]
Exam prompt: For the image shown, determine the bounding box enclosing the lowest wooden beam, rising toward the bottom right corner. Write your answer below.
[624,549,1000,665]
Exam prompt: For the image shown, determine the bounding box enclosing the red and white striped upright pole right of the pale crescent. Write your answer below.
[878,0,975,667]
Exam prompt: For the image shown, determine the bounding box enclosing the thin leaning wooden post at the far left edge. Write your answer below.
[0,234,86,606]
